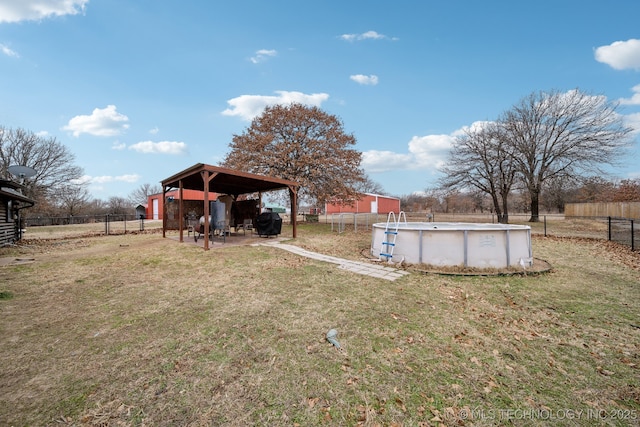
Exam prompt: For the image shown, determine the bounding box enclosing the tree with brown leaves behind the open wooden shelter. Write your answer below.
[222,103,365,216]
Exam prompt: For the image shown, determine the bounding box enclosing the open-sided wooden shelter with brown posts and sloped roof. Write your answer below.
[161,163,300,250]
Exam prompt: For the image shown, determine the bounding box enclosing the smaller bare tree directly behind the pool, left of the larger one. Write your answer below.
[440,123,516,224]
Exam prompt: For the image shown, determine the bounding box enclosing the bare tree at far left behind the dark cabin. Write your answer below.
[0,127,83,209]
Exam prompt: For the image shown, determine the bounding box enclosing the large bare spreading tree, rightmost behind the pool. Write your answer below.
[500,89,632,222]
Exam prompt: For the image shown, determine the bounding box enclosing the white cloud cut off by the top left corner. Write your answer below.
[0,0,89,23]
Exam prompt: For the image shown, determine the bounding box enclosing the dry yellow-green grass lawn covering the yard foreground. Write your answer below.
[0,224,640,426]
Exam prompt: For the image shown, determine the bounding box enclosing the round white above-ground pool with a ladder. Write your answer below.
[371,222,533,268]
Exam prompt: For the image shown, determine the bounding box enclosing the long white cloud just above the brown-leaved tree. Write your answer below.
[222,91,329,120]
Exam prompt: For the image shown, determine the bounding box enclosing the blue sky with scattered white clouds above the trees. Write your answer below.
[0,0,640,200]
